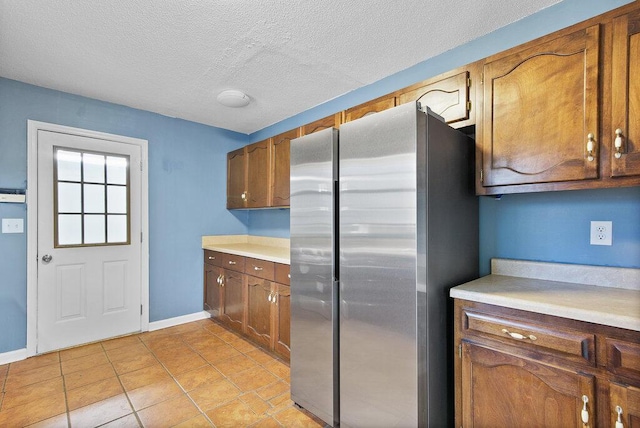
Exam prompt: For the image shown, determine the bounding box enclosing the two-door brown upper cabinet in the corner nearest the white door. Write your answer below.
[227,139,271,209]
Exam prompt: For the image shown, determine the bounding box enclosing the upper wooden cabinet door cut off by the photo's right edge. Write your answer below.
[605,10,640,177]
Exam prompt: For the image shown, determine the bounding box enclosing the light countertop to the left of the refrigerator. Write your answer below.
[202,235,290,265]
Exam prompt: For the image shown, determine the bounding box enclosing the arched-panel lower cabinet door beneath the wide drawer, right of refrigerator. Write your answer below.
[462,342,597,428]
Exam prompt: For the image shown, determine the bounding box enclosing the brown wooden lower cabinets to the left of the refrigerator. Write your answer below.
[204,250,291,361]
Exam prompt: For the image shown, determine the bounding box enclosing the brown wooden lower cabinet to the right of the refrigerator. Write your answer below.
[454,299,640,428]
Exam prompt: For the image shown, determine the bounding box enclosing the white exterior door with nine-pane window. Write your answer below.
[36,129,142,354]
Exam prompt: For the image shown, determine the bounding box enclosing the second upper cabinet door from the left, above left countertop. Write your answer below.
[245,140,271,208]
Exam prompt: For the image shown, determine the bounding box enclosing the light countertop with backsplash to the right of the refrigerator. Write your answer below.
[450,259,640,331]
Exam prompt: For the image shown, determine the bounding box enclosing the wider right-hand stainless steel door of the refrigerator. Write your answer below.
[339,103,426,427]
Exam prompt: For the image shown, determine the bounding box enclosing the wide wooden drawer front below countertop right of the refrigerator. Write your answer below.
[464,310,595,365]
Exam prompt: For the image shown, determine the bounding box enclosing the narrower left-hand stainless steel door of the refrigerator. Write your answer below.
[290,129,338,425]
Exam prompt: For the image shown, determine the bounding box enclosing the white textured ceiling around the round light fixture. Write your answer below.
[0,0,559,133]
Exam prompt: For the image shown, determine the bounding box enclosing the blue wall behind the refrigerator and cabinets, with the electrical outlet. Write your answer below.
[249,0,640,275]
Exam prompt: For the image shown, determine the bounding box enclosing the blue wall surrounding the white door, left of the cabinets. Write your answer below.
[0,78,248,353]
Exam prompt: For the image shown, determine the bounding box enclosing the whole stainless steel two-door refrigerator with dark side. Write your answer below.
[290,103,478,427]
